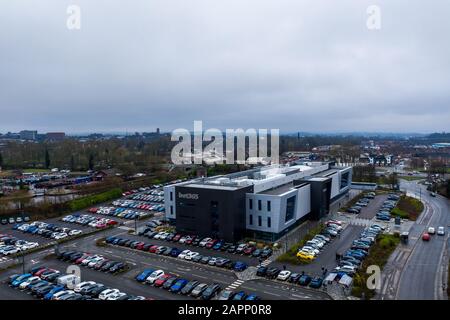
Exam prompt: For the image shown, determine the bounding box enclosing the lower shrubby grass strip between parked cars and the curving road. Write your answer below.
[352,234,400,300]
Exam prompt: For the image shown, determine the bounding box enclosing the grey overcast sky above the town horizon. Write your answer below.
[0,0,450,133]
